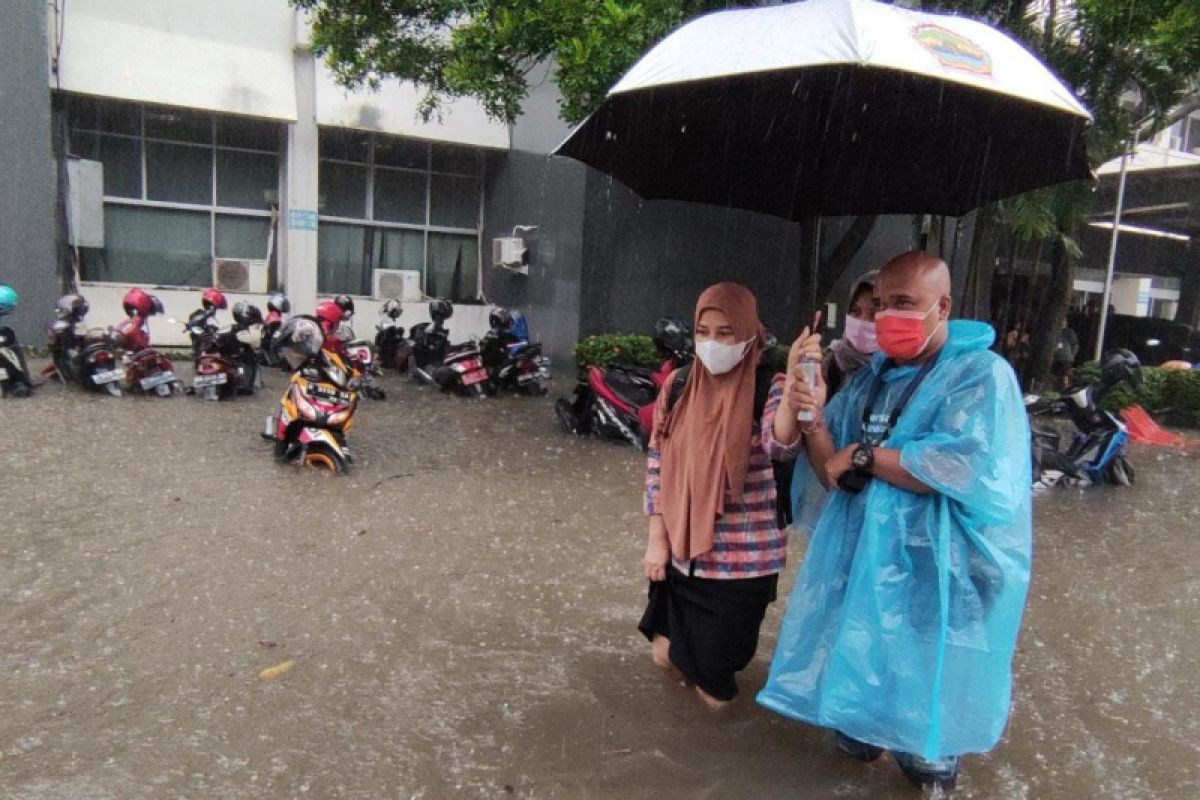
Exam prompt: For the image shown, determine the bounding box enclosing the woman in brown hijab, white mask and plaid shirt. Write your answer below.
[638,283,820,708]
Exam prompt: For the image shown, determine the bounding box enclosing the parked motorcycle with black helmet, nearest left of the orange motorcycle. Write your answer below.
[185,301,263,401]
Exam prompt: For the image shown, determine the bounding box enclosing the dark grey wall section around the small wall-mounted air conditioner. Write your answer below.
[480,150,587,374]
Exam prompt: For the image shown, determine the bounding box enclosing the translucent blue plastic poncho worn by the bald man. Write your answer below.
[758,320,1032,759]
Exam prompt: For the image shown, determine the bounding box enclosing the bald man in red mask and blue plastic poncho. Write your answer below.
[758,252,1032,789]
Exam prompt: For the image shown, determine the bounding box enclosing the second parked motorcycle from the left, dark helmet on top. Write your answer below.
[43,294,125,397]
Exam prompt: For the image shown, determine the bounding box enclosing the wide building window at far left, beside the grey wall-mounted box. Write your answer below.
[64,95,281,287]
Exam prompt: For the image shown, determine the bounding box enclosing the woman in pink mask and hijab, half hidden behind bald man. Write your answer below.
[792,270,880,533]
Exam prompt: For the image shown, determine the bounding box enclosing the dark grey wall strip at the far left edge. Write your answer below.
[0,0,59,344]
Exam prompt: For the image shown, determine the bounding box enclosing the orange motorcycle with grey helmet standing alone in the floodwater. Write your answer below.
[263,315,359,473]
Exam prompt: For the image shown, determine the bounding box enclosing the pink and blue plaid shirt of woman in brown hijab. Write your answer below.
[646,375,800,578]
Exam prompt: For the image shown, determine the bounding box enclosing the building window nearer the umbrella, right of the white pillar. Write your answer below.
[317,127,484,302]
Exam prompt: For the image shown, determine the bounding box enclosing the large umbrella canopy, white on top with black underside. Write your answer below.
[556,0,1091,219]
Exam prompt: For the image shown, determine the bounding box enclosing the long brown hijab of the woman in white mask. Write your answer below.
[654,283,763,559]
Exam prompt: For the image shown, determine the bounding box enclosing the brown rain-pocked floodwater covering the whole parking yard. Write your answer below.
[0,369,1200,800]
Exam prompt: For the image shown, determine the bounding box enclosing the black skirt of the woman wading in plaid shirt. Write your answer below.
[637,566,779,700]
